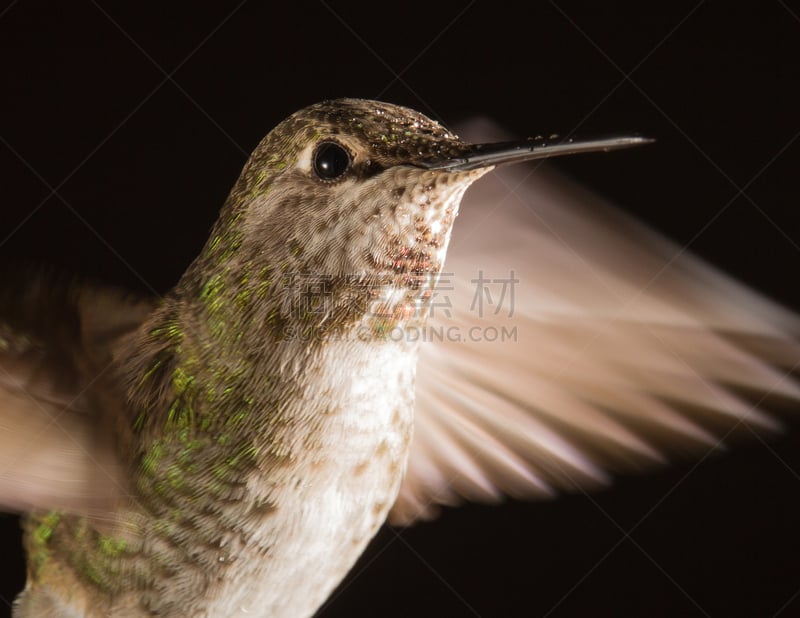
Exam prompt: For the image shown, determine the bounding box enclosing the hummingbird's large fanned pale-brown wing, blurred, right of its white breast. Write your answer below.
[390,119,800,524]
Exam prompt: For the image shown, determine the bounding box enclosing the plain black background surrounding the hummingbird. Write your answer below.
[0,0,800,617]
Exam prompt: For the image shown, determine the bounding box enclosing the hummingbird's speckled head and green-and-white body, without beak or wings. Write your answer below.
[10,101,485,616]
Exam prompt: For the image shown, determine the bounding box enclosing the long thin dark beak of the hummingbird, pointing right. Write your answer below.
[417,137,654,172]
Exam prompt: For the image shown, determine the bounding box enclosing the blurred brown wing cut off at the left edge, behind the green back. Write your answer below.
[0,277,150,514]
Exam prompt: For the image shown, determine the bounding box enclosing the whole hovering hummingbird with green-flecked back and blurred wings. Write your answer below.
[0,99,800,618]
